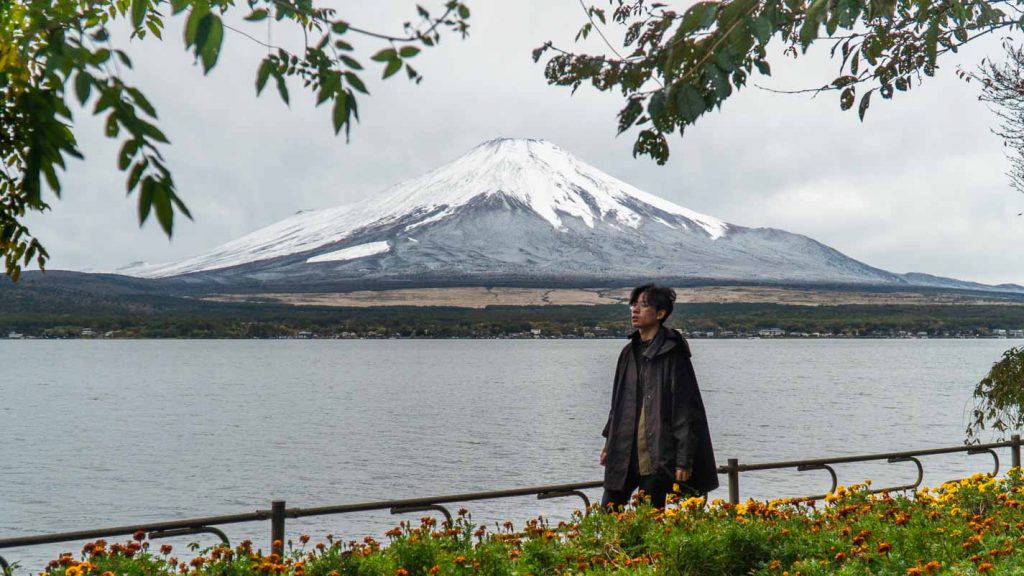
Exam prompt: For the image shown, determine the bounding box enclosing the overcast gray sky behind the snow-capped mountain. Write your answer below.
[22,0,1024,284]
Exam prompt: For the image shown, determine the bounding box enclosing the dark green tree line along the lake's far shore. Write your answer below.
[0,296,1024,338]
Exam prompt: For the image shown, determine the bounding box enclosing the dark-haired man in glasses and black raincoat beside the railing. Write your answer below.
[601,284,718,508]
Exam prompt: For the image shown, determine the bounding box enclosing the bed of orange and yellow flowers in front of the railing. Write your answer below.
[24,468,1024,576]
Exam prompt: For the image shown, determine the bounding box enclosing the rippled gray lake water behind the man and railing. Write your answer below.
[0,340,1024,574]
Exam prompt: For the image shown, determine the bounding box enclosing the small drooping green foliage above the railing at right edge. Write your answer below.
[967,347,1024,443]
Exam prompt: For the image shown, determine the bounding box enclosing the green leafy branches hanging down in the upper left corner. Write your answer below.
[0,0,469,281]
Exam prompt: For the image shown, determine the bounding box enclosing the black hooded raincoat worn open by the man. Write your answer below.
[601,326,718,494]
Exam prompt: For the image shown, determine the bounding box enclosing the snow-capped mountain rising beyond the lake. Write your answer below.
[116,138,1024,291]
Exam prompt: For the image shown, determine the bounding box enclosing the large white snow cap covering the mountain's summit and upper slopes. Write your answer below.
[125,138,729,278]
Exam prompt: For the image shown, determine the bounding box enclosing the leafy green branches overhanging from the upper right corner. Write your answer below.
[534,0,1024,164]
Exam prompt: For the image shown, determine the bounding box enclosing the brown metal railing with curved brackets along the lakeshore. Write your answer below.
[0,435,1021,574]
